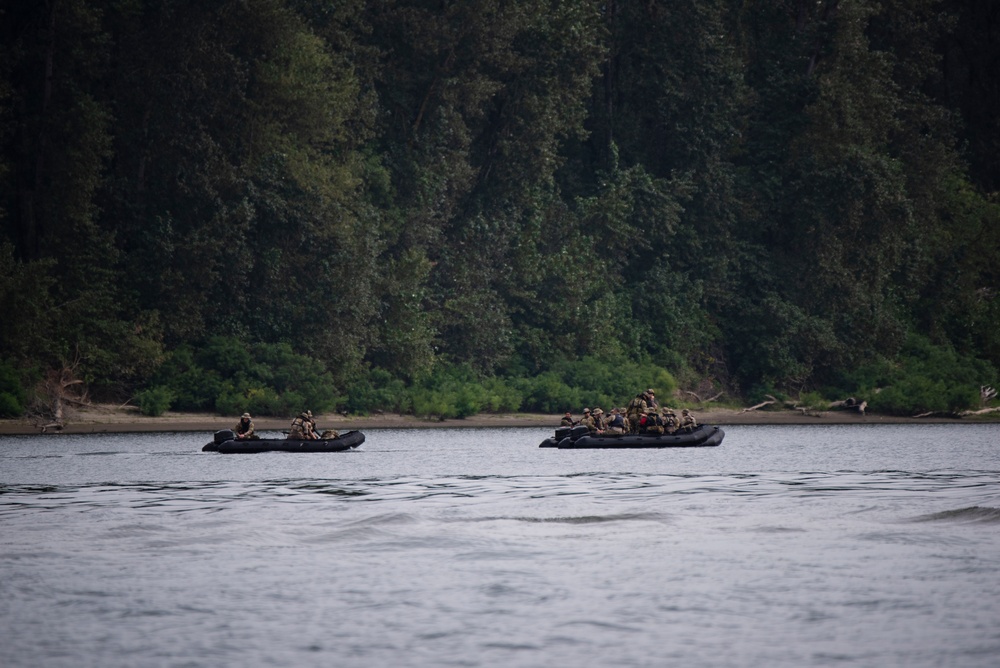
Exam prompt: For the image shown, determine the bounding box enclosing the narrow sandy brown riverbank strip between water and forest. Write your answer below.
[0,405,984,434]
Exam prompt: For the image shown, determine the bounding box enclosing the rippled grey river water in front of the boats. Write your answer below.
[0,425,1000,668]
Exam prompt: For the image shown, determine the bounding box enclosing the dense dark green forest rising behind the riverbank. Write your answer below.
[0,0,1000,416]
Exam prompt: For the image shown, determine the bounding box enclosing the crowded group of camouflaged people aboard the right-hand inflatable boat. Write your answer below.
[560,389,698,436]
